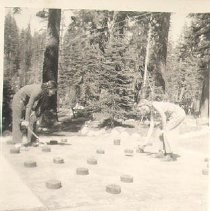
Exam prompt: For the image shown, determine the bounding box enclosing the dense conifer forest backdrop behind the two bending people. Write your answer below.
[3,10,210,130]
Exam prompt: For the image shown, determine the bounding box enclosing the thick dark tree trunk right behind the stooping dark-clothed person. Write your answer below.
[42,9,61,122]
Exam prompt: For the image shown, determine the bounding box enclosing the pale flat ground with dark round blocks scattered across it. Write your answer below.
[0,118,209,211]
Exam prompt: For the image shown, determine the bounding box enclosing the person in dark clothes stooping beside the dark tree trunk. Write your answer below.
[12,81,56,147]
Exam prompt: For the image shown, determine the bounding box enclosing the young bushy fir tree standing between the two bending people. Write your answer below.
[99,37,131,124]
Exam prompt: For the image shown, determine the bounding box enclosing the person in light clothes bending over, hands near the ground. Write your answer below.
[137,99,186,161]
